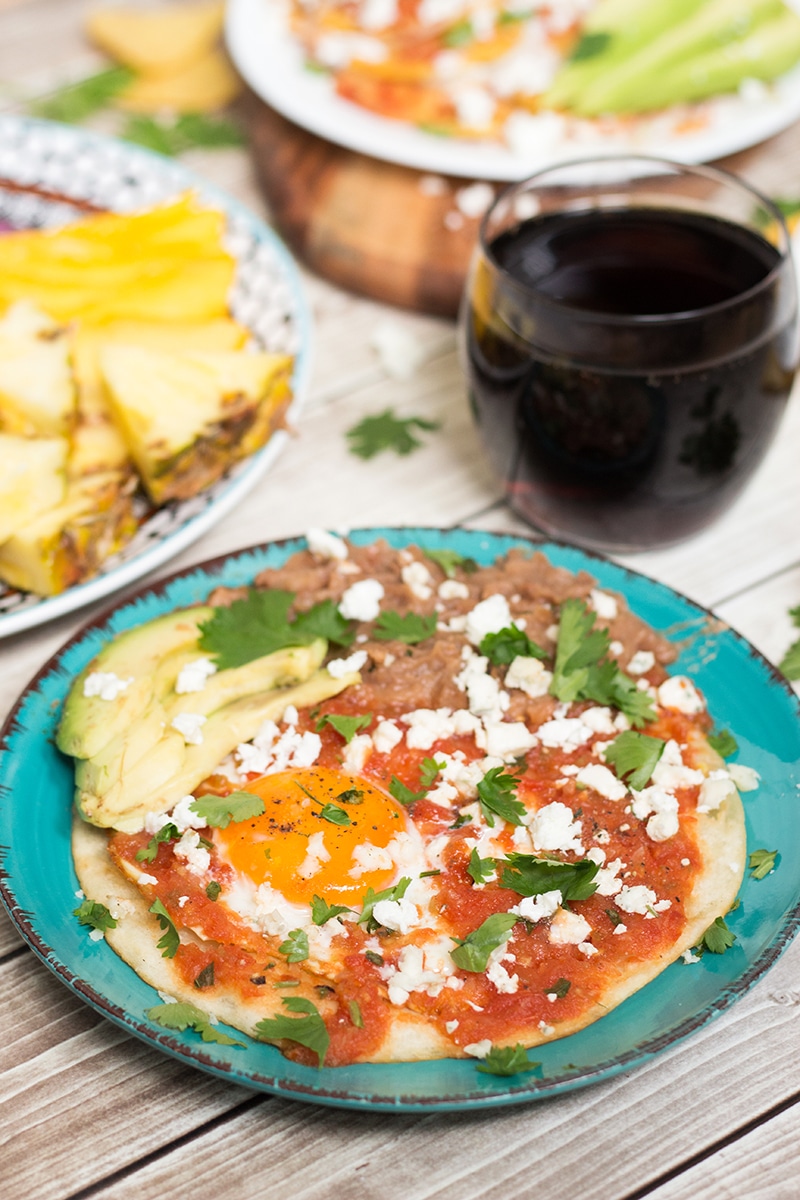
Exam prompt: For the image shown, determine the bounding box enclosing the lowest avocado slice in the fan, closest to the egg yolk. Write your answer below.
[76,670,361,833]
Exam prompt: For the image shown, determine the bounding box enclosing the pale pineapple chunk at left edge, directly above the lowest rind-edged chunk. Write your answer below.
[0,433,70,544]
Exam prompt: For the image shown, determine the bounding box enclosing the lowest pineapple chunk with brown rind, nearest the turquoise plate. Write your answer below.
[0,472,137,595]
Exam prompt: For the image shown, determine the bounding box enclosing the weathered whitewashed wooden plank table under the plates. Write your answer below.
[0,0,800,1200]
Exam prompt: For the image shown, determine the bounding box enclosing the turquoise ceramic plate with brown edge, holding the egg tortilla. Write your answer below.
[0,529,800,1111]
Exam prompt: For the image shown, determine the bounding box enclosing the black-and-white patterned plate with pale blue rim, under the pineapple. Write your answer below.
[0,116,311,637]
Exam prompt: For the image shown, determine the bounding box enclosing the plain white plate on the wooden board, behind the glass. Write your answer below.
[225,0,800,181]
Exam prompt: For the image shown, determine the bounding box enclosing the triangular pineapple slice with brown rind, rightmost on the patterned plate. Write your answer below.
[100,344,291,504]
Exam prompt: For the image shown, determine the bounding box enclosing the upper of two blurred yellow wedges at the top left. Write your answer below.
[86,0,224,74]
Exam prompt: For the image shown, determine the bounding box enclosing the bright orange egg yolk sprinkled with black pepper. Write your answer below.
[215,767,407,906]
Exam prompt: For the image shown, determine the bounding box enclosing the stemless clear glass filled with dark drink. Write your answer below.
[463,208,795,550]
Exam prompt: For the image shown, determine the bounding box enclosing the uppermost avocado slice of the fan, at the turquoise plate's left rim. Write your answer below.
[56,606,213,758]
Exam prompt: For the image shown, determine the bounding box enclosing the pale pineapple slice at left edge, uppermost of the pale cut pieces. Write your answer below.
[0,300,76,438]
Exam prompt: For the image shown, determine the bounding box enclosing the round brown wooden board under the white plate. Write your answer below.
[245,96,489,317]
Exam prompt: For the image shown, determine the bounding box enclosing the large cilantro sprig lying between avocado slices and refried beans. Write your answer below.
[198,588,354,670]
